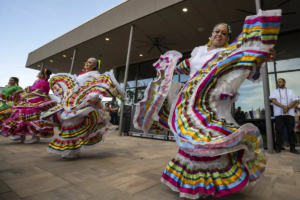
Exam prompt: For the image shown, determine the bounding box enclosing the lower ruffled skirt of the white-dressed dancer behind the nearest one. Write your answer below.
[47,106,117,155]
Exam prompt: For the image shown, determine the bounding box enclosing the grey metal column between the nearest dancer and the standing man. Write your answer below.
[255,0,274,154]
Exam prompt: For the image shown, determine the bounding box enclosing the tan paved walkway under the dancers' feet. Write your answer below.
[0,132,300,200]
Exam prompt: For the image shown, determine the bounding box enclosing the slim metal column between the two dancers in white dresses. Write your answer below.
[119,25,133,136]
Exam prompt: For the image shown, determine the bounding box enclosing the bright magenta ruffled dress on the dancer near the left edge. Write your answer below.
[0,79,57,138]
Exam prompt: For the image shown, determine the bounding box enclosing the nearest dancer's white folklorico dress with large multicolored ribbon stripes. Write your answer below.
[134,10,281,199]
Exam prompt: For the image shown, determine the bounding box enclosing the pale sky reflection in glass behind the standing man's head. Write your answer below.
[277,71,300,96]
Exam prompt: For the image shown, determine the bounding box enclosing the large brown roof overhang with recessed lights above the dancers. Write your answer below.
[26,0,300,73]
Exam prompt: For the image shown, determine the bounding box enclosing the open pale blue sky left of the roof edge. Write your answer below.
[0,0,124,88]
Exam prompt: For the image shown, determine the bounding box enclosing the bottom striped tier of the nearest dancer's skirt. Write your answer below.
[161,149,249,199]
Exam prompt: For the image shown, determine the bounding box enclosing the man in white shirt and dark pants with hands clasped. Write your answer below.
[270,78,299,154]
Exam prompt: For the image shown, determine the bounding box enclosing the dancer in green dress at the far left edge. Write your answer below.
[0,77,22,126]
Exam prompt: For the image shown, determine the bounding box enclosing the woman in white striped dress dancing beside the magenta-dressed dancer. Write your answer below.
[42,58,126,158]
